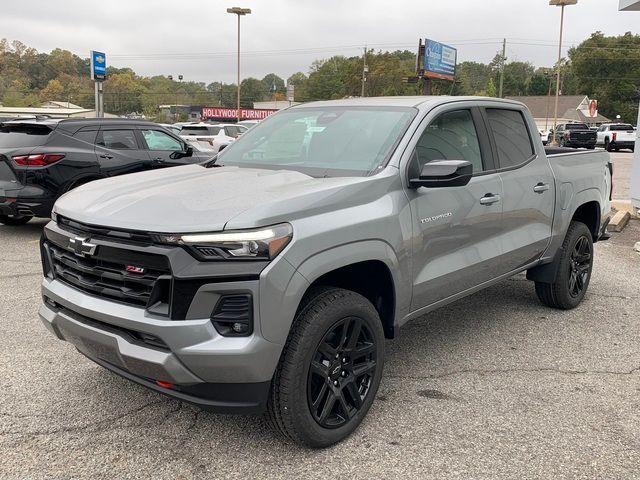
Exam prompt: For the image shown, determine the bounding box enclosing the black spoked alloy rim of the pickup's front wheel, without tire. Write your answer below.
[307,317,377,428]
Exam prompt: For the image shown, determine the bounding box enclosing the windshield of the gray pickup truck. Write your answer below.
[218,107,417,177]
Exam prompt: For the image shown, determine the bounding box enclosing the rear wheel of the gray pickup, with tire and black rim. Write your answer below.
[536,222,593,310]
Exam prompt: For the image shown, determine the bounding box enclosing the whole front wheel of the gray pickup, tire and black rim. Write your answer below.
[266,287,384,448]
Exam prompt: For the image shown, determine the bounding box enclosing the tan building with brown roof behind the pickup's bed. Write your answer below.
[506,95,611,131]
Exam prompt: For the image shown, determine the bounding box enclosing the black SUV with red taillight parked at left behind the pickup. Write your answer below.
[0,118,212,225]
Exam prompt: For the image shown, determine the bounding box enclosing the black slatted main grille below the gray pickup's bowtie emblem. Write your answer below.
[46,242,171,307]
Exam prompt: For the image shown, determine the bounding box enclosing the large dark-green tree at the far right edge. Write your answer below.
[563,32,640,123]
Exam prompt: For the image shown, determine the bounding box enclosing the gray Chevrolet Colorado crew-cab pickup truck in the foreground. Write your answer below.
[40,97,611,447]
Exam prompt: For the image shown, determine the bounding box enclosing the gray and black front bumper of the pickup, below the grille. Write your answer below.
[40,278,282,413]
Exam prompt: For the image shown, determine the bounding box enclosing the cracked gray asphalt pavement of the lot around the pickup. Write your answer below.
[0,221,640,479]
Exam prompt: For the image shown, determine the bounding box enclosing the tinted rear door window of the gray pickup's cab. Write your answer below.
[486,108,534,168]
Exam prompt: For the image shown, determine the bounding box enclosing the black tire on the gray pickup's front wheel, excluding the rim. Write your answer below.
[265,287,384,448]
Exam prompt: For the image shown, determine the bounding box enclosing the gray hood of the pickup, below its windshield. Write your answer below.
[54,165,380,233]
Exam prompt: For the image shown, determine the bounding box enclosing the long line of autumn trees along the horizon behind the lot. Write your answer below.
[0,32,640,122]
